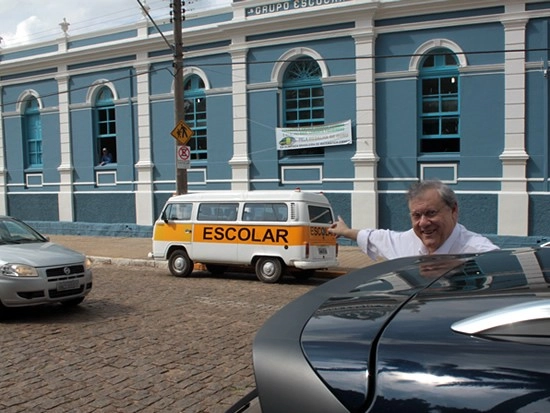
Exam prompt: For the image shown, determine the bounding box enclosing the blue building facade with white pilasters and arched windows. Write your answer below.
[0,0,550,241]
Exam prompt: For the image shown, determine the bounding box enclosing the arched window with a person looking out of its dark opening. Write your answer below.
[94,87,117,164]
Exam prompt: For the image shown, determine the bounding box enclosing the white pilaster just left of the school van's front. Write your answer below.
[135,64,155,225]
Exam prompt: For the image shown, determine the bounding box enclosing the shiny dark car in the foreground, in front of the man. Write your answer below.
[229,248,550,413]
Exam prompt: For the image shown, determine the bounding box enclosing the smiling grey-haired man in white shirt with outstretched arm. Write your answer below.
[329,180,499,259]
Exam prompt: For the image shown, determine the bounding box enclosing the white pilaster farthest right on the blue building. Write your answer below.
[498,13,529,236]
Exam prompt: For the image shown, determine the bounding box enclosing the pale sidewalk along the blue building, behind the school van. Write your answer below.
[48,235,374,275]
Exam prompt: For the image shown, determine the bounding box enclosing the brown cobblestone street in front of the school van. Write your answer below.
[0,264,326,413]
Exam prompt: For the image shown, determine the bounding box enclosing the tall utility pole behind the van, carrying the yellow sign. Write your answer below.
[172,0,187,195]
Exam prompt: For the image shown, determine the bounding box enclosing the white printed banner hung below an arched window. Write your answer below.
[275,120,351,151]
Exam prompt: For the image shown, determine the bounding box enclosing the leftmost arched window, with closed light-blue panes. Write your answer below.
[23,97,42,168]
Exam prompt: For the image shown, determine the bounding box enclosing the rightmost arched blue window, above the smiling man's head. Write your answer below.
[419,48,460,153]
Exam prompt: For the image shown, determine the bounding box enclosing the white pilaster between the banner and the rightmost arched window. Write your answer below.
[351,14,379,228]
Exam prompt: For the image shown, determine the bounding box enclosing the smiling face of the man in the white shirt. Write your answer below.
[409,189,458,254]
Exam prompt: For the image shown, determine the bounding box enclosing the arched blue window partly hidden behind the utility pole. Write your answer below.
[184,74,208,159]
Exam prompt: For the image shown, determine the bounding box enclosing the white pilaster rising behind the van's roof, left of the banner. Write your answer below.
[229,38,250,190]
